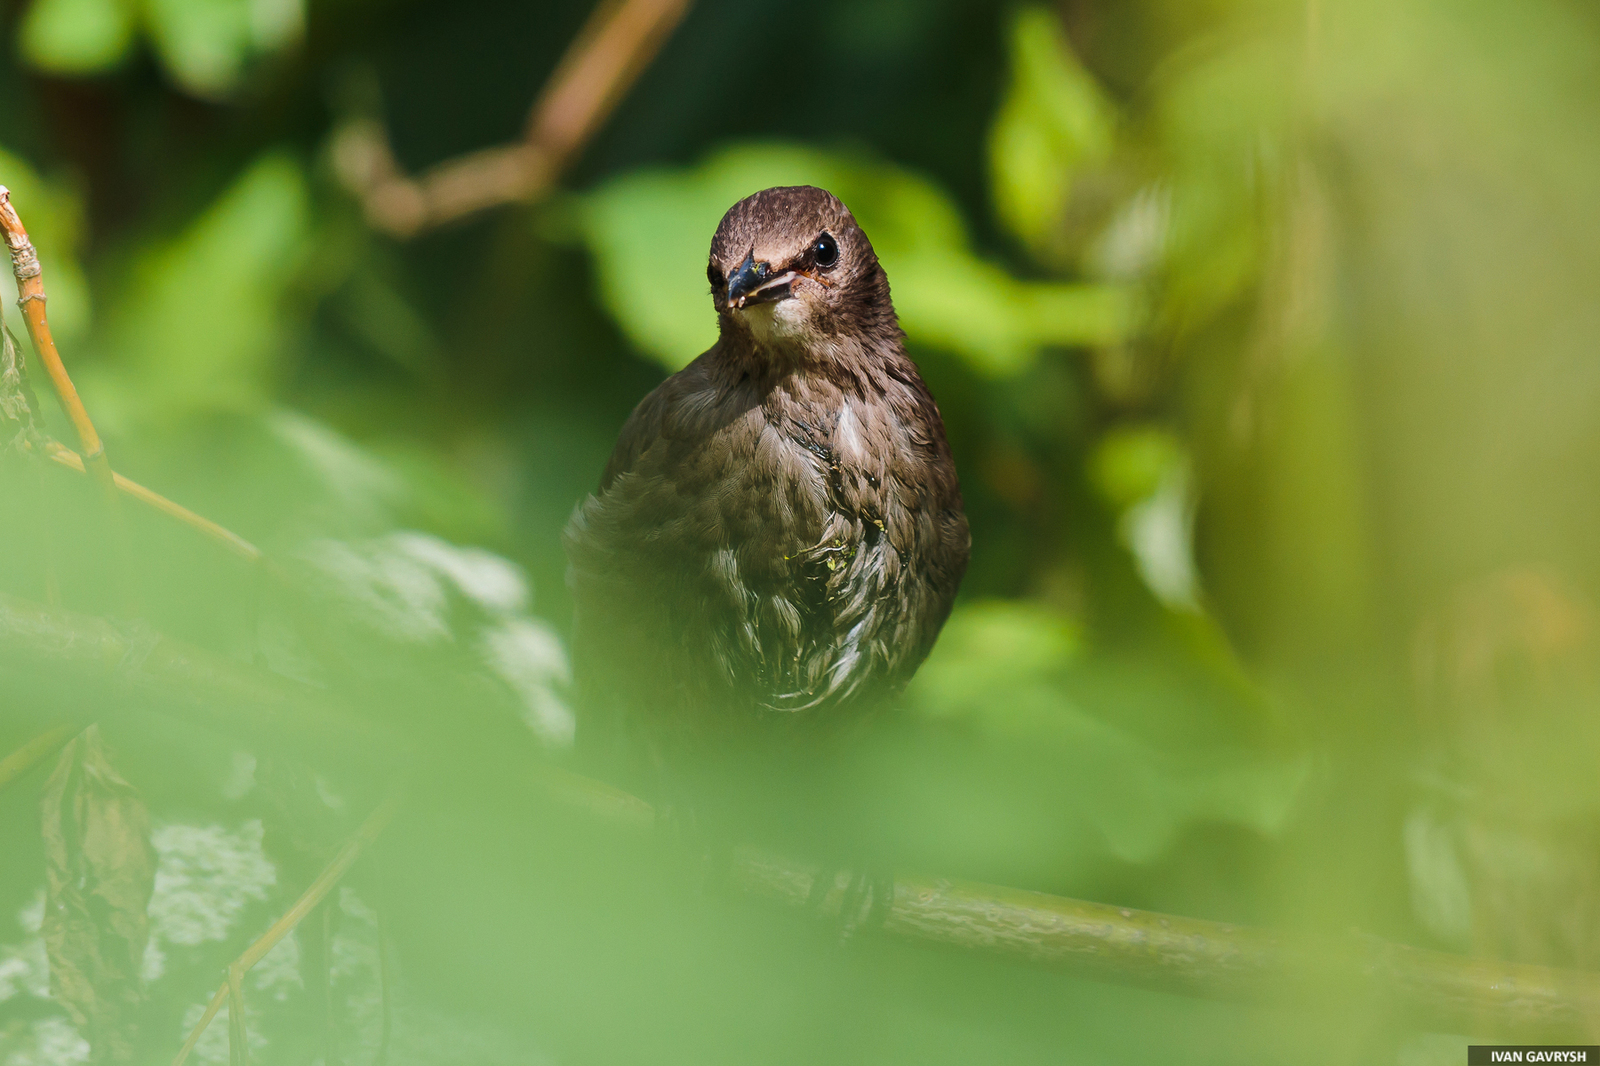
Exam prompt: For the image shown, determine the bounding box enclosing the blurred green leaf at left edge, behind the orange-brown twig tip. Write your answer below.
[0,149,90,344]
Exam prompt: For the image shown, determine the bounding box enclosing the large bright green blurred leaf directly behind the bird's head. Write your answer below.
[581,144,1133,375]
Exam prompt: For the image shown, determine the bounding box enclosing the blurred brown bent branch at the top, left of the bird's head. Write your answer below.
[334,0,690,237]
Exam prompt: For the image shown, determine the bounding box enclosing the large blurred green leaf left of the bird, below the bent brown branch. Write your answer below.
[83,154,307,421]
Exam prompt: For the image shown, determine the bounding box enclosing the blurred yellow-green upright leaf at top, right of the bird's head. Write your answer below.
[989,6,1115,251]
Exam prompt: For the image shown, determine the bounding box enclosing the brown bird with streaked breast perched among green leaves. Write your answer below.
[563,186,971,857]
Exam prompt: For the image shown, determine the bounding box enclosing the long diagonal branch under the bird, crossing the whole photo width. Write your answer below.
[0,595,1600,1042]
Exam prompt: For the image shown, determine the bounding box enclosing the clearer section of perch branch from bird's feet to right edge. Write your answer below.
[734,852,1600,1042]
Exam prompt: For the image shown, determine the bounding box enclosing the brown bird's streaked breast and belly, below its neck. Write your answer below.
[568,358,965,729]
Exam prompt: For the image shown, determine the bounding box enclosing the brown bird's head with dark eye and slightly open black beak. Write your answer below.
[706,186,898,352]
